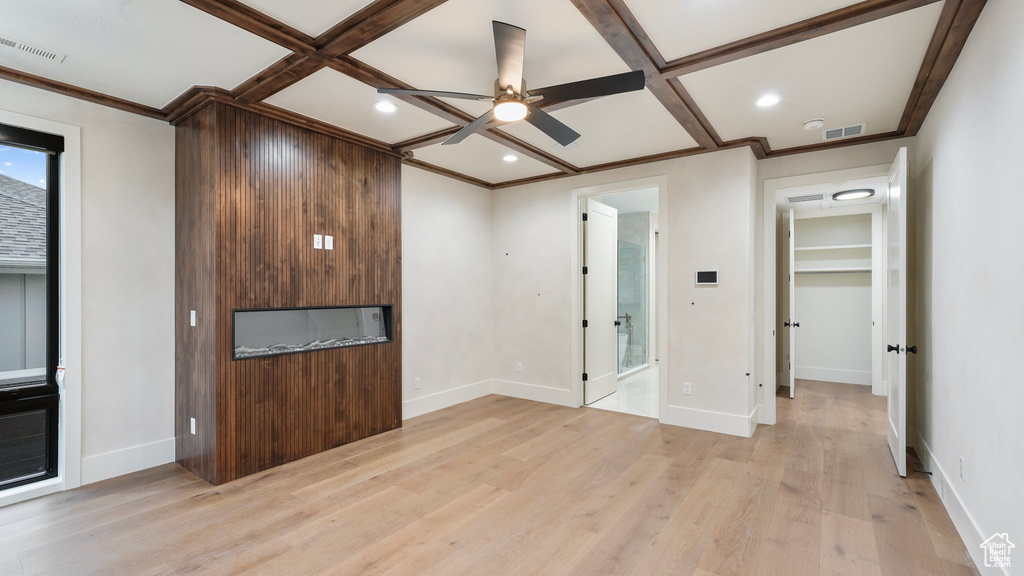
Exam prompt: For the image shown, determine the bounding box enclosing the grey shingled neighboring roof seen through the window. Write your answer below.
[0,170,46,263]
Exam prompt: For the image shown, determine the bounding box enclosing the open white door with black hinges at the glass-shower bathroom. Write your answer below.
[583,199,618,404]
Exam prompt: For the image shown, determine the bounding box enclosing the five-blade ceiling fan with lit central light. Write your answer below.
[377,20,645,147]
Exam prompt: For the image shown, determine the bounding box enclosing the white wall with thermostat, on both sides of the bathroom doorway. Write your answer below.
[494,149,756,435]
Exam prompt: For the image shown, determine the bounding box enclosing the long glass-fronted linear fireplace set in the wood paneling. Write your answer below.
[233,305,391,360]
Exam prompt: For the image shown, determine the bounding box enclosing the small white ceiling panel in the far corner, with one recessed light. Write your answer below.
[414,134,557,183]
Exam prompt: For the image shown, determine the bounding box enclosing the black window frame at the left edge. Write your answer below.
[0,123,65,491]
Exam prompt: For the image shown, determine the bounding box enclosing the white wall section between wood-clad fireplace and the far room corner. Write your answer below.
[401,166,496,418]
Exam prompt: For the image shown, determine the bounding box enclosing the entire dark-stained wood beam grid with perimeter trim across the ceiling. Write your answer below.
[0,0,986,190]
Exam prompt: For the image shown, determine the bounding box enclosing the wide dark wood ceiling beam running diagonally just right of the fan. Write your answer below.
[572,0,721,150]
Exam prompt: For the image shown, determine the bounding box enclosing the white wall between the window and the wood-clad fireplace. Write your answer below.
[0,81,174,483]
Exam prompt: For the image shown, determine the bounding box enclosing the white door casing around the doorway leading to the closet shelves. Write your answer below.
[758,164,892,424]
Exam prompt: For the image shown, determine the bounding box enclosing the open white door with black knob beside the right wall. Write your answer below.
[886,148,916,477]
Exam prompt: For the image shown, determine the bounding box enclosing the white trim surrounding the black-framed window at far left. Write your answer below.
[0,110,82,506]
